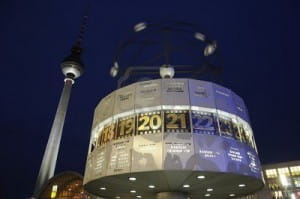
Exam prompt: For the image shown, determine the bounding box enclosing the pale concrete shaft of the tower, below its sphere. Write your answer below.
[33,77,74,198]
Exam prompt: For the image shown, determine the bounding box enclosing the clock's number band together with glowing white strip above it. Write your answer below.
[89,105,257,152]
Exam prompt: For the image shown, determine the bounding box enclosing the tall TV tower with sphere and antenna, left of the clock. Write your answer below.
[33,15,88,198]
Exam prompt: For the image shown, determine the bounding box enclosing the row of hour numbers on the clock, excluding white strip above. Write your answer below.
[95,109,255,150]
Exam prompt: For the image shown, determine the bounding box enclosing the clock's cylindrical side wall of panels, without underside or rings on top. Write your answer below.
[85,79,260,181]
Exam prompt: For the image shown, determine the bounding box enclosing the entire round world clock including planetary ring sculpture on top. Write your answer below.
[84,22,263,199]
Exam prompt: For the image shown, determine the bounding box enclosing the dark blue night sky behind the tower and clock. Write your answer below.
[0,0,300,199]
